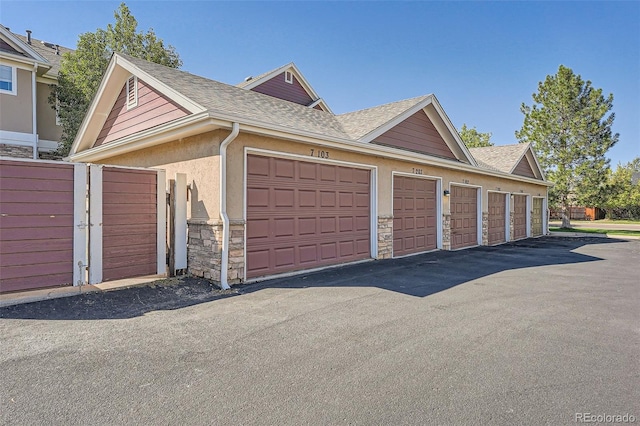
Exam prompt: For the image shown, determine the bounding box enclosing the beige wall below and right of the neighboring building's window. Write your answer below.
[0,69,33,133]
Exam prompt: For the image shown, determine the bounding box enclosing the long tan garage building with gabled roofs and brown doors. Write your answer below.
[70,54,551,285]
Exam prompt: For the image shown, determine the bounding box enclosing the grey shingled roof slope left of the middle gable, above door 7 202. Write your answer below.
[337,95,429,140]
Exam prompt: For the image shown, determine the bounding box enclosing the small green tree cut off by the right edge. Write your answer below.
[598,157,640,219]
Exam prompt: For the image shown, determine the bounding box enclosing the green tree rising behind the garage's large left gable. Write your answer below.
[49,3,182,156]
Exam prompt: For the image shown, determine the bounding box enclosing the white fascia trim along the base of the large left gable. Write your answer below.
[69,113,215,161]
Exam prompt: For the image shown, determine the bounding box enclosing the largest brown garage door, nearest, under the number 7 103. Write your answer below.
[246,155,371,278]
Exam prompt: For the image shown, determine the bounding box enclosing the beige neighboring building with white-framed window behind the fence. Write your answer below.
[0,25,71,158]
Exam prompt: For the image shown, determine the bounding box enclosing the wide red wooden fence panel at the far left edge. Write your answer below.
[0,160,74,293]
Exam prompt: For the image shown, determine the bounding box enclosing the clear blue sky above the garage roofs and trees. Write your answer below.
[0,0,640,166]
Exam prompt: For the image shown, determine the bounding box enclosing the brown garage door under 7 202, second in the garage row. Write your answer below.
[393,176,438,256]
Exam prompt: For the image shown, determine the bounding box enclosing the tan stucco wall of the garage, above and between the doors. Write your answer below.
[92,130,546,235]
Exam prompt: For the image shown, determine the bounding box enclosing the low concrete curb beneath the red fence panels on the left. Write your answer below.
[0,275,166,308]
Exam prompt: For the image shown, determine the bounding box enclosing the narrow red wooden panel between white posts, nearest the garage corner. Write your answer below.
[102,167,158,281]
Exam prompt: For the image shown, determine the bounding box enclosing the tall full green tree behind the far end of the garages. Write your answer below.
[516,65,619,227]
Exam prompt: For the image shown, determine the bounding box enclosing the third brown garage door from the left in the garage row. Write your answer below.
[449,185,478,249]
